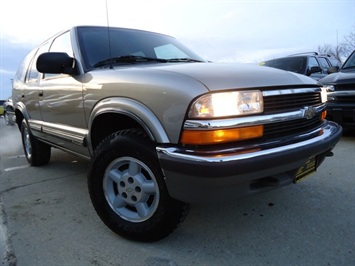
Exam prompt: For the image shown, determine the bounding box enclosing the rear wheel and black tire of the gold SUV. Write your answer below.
[21,119,51,166]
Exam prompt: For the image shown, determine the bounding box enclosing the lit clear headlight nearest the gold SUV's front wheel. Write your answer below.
[188,90,264,118]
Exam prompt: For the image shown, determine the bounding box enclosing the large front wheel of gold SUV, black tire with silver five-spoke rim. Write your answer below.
[88,129,189,242]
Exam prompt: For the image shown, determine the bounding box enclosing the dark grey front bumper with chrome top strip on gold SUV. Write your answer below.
[157,122,342,204]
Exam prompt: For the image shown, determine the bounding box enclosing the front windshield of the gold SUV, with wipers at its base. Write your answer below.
[77,27,205,70]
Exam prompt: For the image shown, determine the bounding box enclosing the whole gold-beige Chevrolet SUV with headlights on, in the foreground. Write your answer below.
[13,26,342,241]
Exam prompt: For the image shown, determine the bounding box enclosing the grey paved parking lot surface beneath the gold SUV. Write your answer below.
[0,118,355,266]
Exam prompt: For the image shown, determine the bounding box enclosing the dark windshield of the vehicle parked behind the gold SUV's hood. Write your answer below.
[263,57,307,74]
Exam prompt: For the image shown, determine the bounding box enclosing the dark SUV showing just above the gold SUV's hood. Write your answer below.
[260,52,341,80]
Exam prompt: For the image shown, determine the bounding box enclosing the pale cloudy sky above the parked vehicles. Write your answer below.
[0,0,355,99]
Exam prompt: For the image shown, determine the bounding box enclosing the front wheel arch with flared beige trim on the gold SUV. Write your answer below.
[88,97,170,153]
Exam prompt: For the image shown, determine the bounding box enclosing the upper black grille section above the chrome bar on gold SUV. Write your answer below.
[264,92,322,114]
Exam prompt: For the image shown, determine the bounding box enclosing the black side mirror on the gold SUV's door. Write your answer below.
[36,53,77,74]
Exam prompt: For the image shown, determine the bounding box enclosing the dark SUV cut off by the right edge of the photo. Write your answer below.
[319,51,355,129]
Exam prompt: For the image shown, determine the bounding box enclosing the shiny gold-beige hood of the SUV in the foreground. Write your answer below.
[115,63,318,91]
